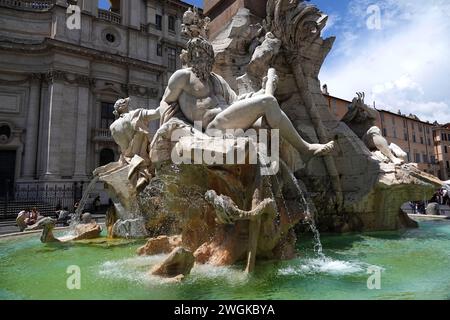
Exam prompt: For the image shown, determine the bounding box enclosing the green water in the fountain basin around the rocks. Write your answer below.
[0,221,450,299]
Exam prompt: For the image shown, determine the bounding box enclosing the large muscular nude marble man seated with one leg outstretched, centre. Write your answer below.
[159,38,335,156]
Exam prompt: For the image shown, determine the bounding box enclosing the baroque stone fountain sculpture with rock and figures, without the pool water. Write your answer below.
[72,0,440,277]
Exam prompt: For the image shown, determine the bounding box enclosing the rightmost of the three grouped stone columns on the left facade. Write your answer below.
[74,86,89,180]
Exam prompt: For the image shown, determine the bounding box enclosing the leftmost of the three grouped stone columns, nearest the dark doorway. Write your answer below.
[22,74,41,179]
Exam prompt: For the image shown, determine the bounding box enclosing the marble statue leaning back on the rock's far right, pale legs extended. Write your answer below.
[342,92,405,165]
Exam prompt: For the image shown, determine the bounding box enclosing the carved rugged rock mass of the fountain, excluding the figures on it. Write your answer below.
[89,0,440,277]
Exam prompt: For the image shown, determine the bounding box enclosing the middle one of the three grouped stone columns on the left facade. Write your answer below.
[43,73,64,180]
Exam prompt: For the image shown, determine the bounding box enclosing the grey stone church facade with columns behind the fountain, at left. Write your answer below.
[0,0,189,208]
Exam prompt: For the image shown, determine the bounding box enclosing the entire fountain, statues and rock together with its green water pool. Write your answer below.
[0,0,450,299]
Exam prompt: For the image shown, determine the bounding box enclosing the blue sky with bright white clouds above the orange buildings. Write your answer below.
[320,0,450,122]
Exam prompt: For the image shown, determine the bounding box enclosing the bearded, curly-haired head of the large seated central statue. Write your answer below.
[183,38,215,80]
